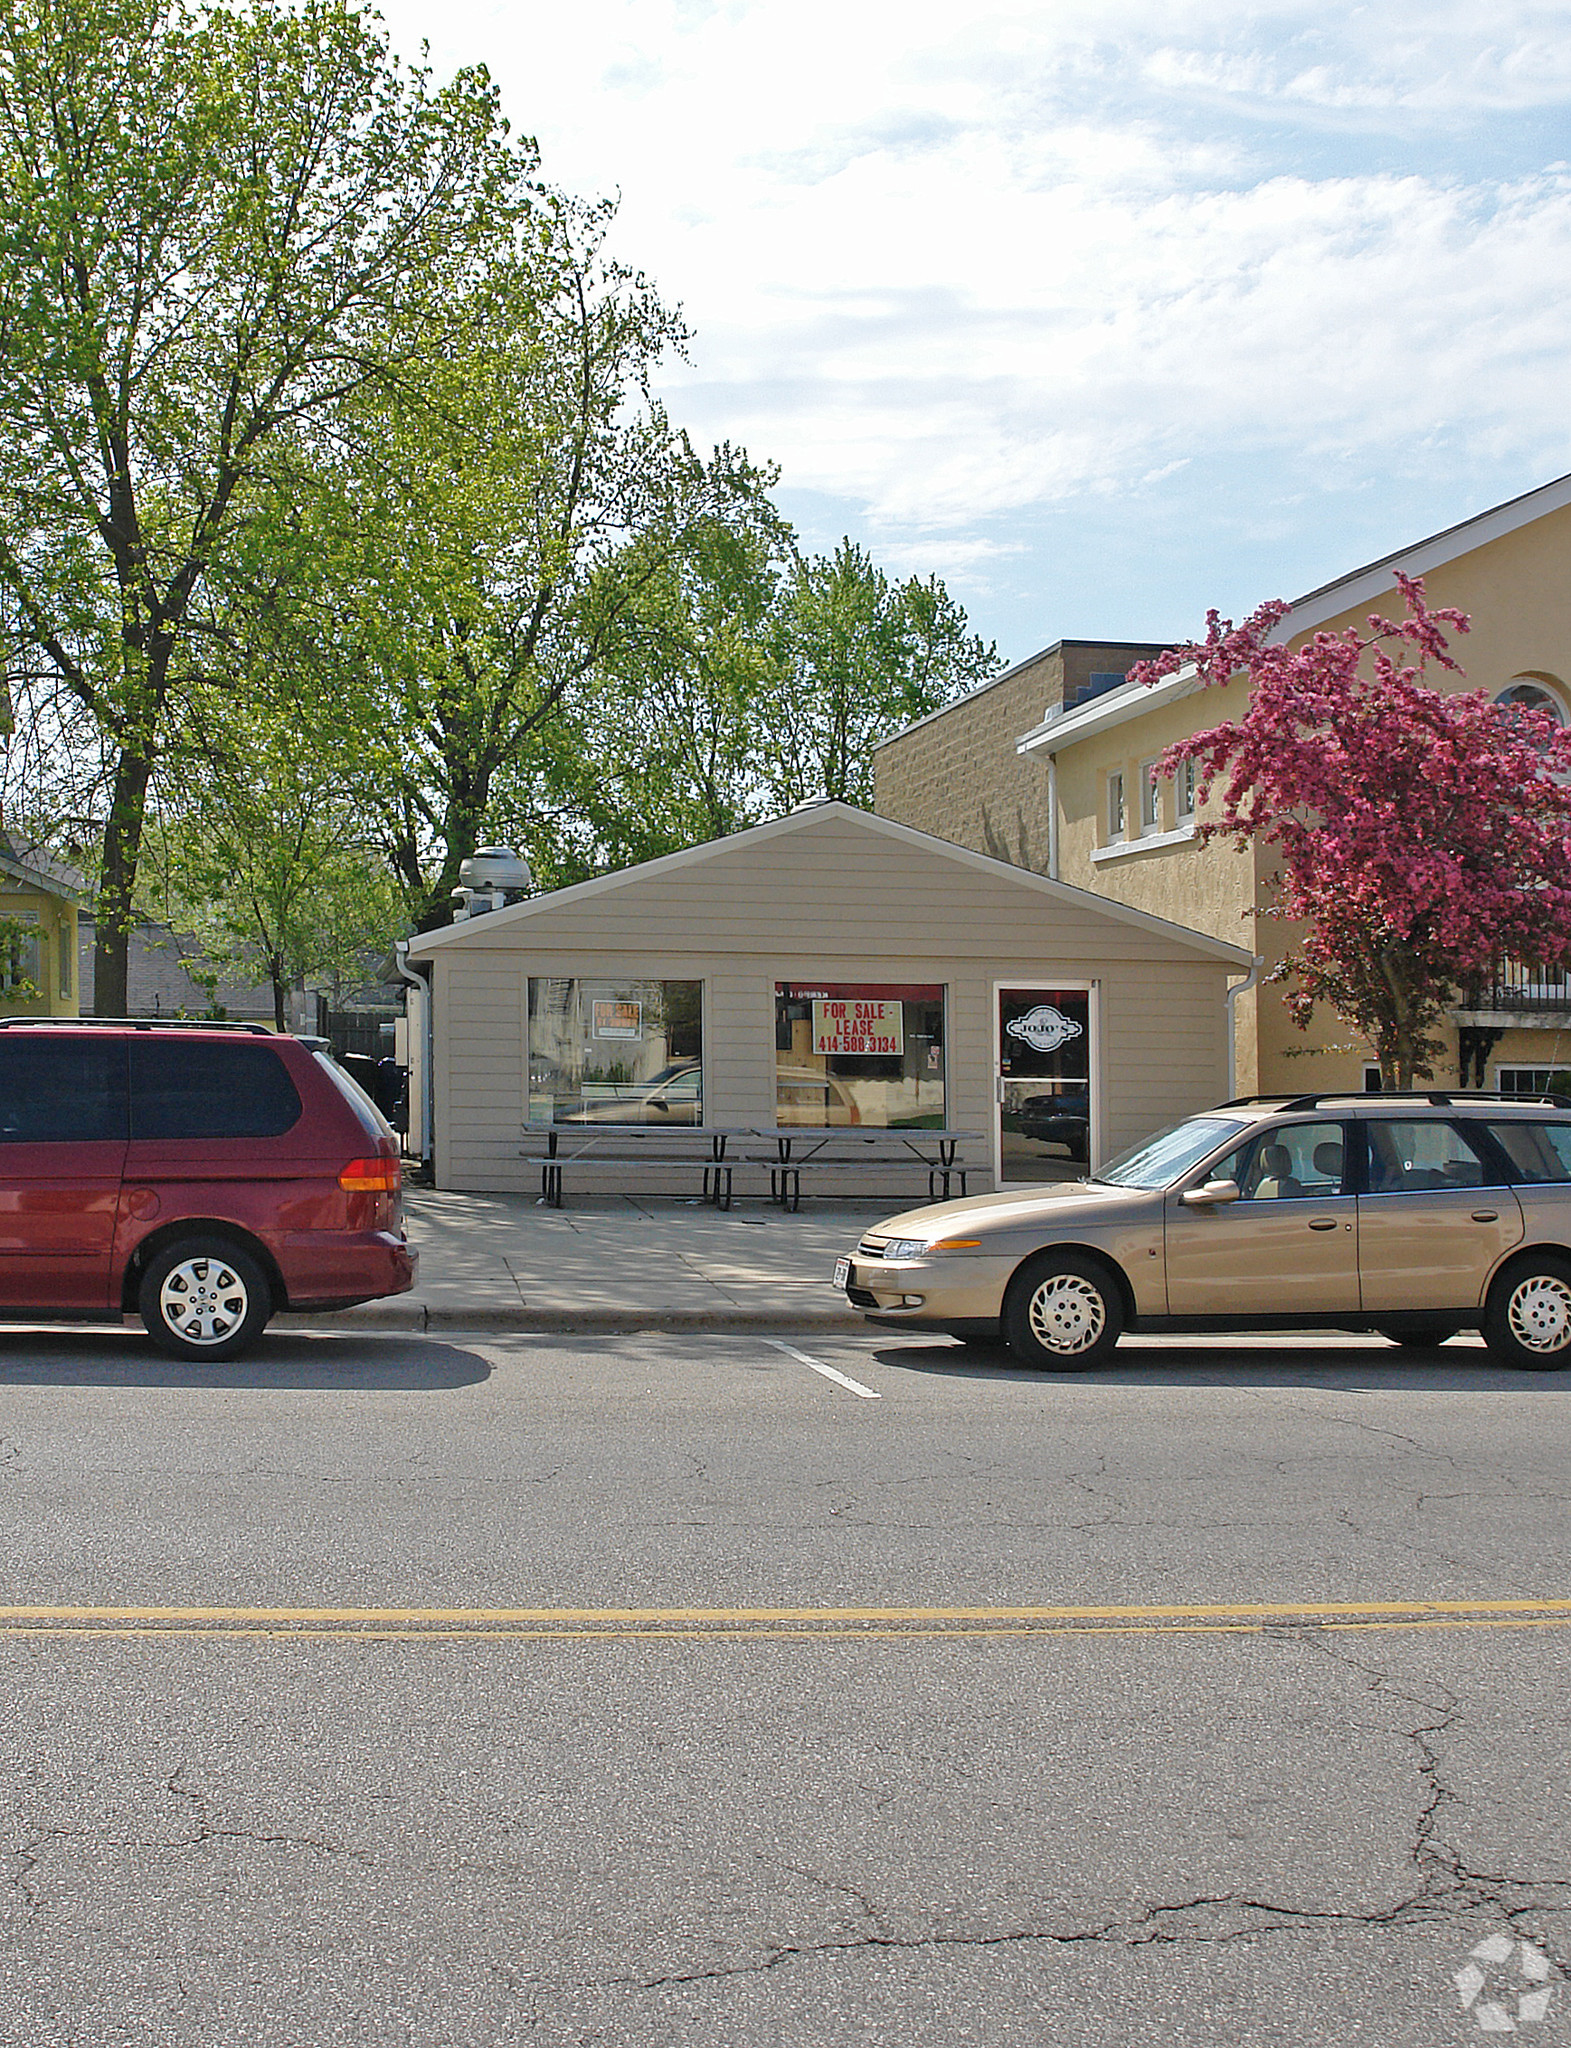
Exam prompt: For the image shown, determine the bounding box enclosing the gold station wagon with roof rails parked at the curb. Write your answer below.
[836,1092,1571,1370]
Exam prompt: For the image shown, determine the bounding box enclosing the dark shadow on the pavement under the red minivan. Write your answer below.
[0,1325,492,1395]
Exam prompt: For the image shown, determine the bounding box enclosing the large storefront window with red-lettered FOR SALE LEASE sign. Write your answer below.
[774,981,944,1130]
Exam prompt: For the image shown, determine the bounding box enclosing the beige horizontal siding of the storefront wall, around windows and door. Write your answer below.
[416,811,1243,1204]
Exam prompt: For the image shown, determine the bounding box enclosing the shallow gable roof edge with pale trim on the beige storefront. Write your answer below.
[408,801,1254,969]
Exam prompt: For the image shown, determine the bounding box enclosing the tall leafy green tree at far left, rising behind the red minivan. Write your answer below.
[0,0,537,1012]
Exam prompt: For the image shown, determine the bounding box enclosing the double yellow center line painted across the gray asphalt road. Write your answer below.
[0,1599,1571,1642]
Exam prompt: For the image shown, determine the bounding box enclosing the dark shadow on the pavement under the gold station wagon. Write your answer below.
[873,1337,1571,1395]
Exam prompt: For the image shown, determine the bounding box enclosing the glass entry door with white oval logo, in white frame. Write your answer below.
[995,989,1092,1184]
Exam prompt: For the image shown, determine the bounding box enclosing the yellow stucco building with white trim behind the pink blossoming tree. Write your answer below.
[875,477,1571,1092]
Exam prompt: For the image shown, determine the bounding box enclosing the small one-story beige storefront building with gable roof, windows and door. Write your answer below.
[408,803,1249,1198]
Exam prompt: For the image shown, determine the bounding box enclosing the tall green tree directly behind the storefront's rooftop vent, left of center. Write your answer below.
[328,201,772,928]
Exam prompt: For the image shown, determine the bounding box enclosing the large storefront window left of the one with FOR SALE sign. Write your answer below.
[528,977,705,1128]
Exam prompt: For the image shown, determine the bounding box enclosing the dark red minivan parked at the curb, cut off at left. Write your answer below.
[0,1018,416,1360]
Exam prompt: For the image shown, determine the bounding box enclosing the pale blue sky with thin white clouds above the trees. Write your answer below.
[381,0,1571,662]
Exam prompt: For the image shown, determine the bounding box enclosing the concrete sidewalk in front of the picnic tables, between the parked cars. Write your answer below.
[283,1188,891,1331]
